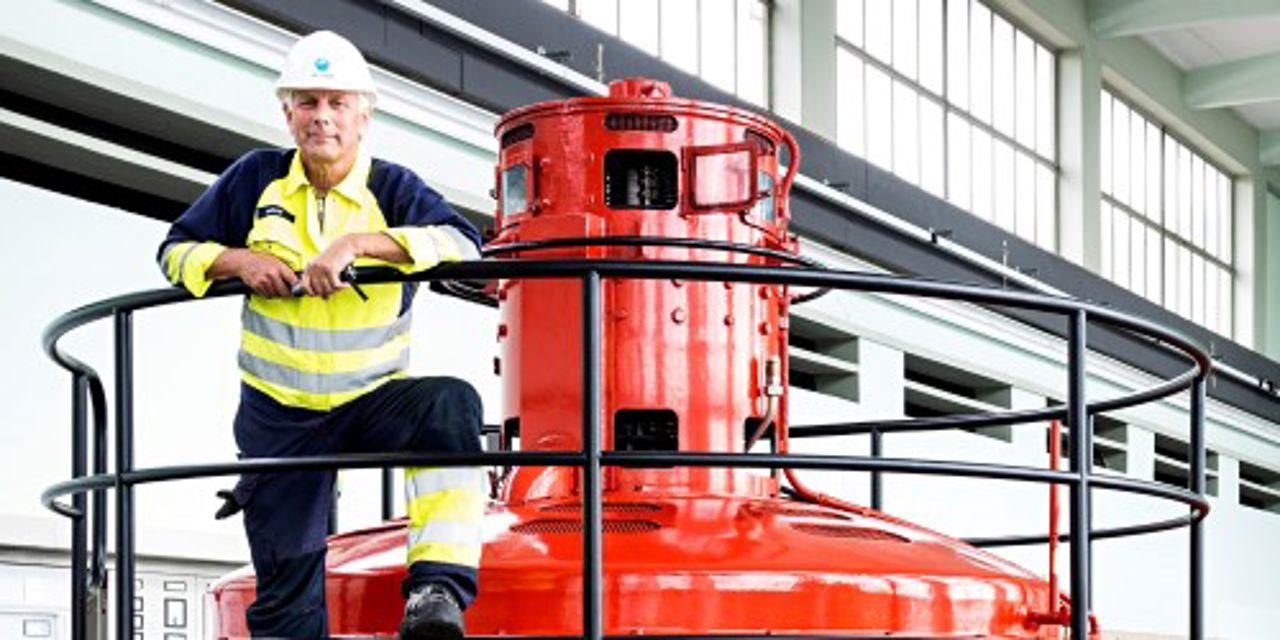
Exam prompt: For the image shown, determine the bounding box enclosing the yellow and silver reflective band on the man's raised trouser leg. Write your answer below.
[404,467,485,567]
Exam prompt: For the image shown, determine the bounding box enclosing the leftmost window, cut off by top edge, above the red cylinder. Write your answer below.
[545,0,769,106]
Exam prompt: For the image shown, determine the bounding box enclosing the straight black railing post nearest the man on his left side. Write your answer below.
[115,311,134,640]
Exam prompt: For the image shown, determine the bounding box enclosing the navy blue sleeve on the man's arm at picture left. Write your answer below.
[156,150,292,260]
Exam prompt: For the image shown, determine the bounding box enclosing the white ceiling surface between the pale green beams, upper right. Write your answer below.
[1142,16,1280,131]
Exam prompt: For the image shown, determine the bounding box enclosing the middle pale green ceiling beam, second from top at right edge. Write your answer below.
[1183,52,1280,109]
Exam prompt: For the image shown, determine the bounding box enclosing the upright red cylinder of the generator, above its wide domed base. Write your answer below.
[490,78,799,503]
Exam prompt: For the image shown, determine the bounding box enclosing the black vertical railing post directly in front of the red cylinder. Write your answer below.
[582,271,604,640]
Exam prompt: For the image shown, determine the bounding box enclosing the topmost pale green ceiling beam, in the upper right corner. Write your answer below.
[1089,0,1280,38]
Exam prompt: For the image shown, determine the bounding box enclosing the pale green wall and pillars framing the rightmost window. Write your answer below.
[992,0,1280,360]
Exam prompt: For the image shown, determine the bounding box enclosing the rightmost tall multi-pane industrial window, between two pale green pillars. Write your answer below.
[1101,90,1235,337]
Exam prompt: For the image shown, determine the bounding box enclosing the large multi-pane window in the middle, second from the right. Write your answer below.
[836,0,1057,251]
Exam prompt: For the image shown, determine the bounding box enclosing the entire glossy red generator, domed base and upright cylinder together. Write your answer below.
[212,79,1090,637]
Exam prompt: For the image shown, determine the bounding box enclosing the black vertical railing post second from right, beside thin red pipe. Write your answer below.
[1066,308,1093,640]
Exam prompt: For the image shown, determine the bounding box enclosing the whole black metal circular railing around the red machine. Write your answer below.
[41,260,1212,640]
